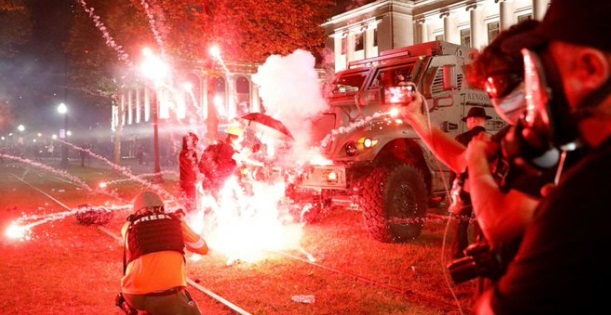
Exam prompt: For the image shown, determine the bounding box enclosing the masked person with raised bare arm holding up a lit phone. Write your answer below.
[400,20,538,252]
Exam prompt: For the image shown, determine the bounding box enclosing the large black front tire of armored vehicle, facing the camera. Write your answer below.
[360,164,427,243]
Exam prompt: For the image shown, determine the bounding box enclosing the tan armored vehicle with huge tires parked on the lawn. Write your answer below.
[295,41,504,242]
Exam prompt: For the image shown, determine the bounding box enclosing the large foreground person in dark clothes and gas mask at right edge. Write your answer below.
[476,0,611,314]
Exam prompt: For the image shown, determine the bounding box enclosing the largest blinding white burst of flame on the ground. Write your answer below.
[191,176,302,265]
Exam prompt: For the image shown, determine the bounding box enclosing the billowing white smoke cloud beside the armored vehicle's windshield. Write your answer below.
[252,49,327,163]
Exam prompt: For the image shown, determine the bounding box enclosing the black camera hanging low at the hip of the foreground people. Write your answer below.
[447,242,506,284]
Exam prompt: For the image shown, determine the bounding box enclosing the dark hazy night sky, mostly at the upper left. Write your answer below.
[0,0,371,138]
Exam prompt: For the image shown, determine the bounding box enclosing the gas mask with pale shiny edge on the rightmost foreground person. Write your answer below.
[504,45,611,172]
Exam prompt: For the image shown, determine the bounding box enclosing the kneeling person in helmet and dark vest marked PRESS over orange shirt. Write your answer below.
[117,191,208,315]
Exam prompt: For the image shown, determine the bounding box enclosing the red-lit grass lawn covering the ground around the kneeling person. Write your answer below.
[0,161,474,315]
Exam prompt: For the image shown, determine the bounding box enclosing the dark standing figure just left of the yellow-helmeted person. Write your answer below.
[178,132,199,213]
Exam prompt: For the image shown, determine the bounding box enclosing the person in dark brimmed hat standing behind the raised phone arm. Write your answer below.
[450,107,492,259]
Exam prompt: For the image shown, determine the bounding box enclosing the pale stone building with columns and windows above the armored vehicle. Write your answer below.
[322,0,549,71]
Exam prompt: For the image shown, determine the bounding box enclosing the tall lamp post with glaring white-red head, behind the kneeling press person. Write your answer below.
[141,48,169,183]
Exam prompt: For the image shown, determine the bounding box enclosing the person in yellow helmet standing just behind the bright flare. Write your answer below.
[199,126,242,197]
